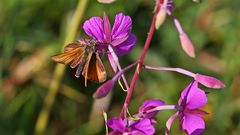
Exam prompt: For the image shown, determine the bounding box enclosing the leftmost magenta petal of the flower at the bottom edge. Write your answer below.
[107,118,126,133]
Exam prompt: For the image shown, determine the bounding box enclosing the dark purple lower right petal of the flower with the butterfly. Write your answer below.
[113,34,137,56]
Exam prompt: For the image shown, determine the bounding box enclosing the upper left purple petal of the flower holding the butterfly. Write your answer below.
[83,17,104,43]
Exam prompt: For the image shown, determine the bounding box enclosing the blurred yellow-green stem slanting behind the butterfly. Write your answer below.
[35,0,88,135]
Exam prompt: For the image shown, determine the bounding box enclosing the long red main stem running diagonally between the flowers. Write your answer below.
[120,0,163,118]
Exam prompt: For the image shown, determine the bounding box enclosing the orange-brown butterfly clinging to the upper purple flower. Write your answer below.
[52,39,107,86]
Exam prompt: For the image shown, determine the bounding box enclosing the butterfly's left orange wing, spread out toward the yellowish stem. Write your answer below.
[52,43,85,68]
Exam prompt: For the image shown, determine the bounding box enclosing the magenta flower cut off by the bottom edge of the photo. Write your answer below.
[107,117,155,135]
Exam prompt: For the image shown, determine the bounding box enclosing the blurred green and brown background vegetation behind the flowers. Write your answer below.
[0,0,240,135]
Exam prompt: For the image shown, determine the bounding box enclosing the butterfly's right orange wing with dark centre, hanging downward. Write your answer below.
[82,53,107,85]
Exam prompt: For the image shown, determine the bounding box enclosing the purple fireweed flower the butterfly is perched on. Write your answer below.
[83,13,136,72]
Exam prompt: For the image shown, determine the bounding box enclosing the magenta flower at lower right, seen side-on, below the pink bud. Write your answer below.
[166,81,207,135]
